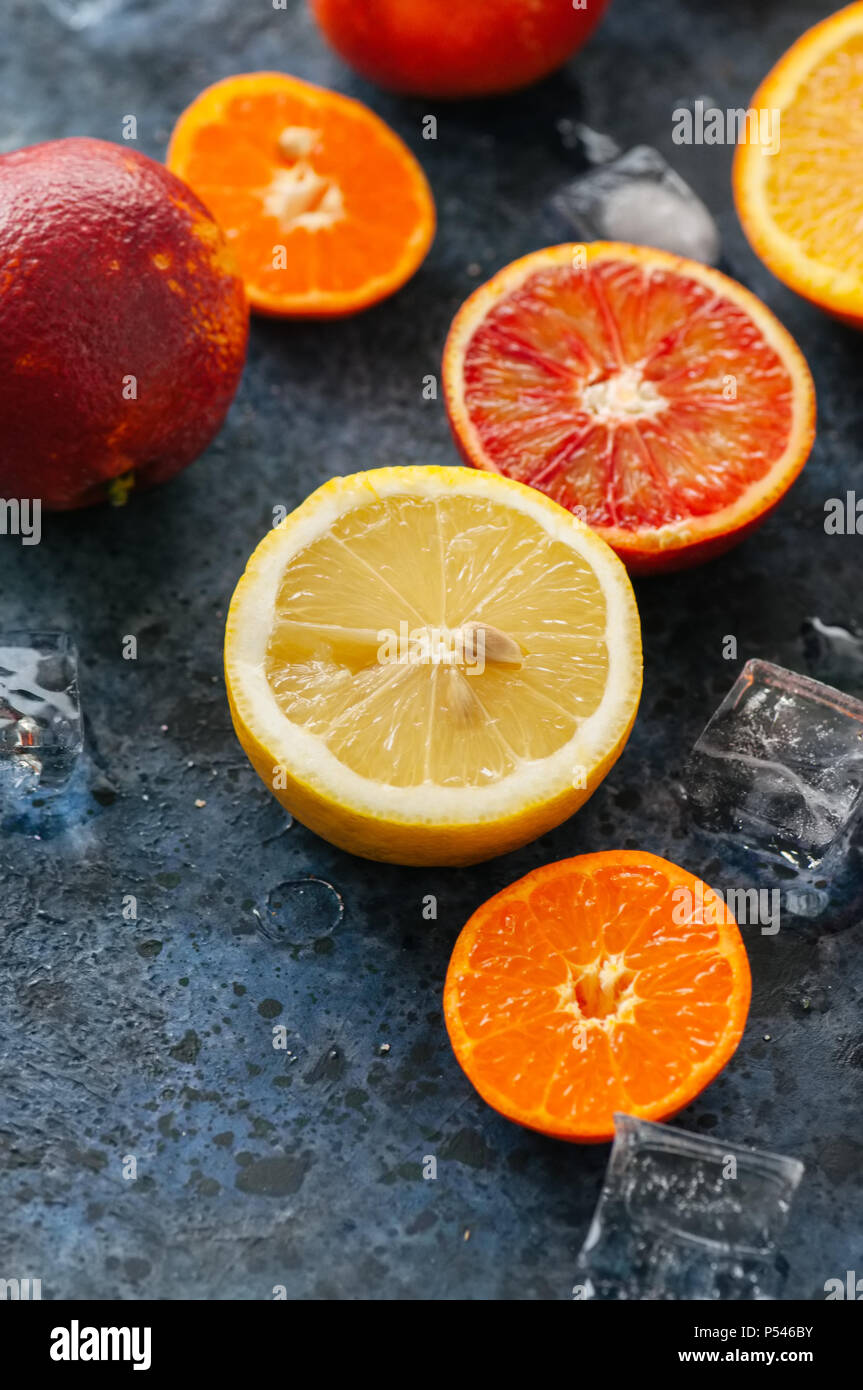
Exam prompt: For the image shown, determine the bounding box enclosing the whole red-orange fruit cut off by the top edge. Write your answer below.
[305,0,607,97]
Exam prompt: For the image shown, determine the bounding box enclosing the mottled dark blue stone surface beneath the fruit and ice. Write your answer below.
[0,0,863,1298]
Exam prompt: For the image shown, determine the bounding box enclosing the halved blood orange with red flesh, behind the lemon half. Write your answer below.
[443,242,814,574]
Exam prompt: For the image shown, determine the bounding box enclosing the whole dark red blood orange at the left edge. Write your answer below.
[0,139,249,510]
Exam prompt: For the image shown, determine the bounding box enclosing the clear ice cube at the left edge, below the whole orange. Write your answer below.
[0,632,83,798]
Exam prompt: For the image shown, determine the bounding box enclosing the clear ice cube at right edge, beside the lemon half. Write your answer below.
[684,660,863,872]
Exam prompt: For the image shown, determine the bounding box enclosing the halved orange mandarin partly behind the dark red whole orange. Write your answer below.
[167,72,435,318]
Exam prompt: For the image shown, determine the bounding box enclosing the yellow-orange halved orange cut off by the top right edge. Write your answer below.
[732,4,863,328]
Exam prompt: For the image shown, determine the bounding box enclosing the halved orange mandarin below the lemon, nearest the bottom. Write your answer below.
[443,849,752,1143]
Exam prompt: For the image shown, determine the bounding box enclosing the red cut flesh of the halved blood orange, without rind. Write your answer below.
[464,260,794,532]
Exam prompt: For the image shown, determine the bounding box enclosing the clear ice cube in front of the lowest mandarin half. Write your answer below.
[574,1115,803,1300]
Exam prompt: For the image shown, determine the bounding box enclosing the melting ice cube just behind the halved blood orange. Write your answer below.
[550,145,720,265]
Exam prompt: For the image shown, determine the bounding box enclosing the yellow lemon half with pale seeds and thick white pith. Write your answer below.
[225,467,642,865]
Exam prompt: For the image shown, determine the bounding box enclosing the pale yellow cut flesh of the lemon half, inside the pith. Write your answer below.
[265,493,609,788]
